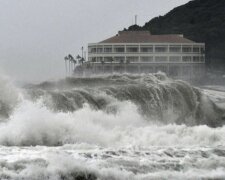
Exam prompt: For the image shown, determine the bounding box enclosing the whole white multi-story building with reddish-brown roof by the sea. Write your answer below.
[81,31,205,77]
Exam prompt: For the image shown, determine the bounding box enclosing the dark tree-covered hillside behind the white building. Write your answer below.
[125,0,225,68]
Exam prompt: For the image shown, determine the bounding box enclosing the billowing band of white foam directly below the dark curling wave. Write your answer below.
[0,97,225,147]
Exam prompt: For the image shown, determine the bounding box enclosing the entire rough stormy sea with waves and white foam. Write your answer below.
[0,73,225,180]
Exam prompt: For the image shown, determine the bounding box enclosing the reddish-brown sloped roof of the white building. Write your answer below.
[100,31,194,43]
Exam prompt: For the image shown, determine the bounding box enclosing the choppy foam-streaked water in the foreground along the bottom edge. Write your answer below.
[0,145,225,180]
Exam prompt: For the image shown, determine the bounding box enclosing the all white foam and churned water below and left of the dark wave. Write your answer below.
[0,73,225,180]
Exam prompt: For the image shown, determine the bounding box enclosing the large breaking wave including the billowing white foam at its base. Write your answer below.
[0,74,225,148]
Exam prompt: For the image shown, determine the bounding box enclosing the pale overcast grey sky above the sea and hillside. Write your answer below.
[0,0,189,81]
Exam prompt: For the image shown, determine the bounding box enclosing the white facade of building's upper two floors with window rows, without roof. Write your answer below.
[88,43,205,64]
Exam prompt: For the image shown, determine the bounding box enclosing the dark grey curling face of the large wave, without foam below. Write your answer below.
[26,73,224,127]
